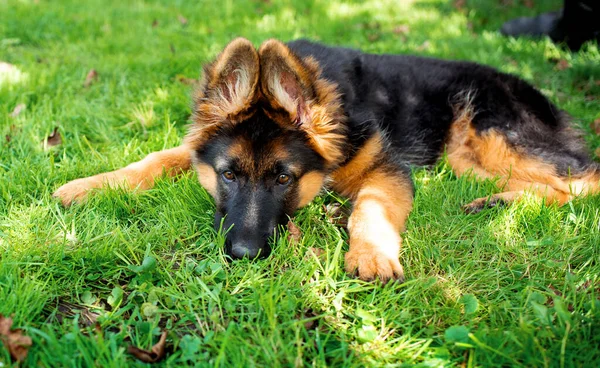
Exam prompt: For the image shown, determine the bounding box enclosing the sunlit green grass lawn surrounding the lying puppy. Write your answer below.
[0,0,600,367]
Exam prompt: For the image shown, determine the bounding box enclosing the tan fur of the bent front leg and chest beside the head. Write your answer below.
[331,134,412,282]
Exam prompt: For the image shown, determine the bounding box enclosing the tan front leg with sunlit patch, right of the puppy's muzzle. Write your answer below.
[346,169,413,282]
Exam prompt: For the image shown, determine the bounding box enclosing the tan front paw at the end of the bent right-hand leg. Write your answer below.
[346,245,404,283]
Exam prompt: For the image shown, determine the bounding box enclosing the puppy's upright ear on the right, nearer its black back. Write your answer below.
[258,40,318,126]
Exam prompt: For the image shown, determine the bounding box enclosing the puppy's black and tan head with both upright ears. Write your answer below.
[186,38,345,258]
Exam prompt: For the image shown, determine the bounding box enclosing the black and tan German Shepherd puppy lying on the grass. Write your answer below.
[54,38,600,281]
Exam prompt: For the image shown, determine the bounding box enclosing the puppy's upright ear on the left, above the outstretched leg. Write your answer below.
[194,38,260,124]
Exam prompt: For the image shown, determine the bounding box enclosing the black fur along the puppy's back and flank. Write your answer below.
[288,40,596,176]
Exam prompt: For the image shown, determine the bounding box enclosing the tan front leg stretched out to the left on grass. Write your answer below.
[53,145,191,206]
